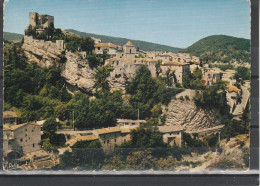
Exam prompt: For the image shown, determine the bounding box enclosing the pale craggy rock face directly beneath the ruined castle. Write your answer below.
[22,36,64,67]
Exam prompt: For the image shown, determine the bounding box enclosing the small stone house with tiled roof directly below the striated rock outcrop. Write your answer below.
[158,125,184,147]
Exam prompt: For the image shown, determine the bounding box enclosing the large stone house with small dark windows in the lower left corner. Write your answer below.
[3,123,41,154]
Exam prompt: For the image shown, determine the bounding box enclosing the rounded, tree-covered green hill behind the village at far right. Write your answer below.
[180,35,250,62]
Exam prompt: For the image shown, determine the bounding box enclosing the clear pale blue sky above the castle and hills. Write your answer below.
[4,0,250,48]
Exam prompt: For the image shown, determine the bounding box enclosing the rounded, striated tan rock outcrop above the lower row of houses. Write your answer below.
[162,99,221,131]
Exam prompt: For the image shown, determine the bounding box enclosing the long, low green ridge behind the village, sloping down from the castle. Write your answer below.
[66,29,180,52]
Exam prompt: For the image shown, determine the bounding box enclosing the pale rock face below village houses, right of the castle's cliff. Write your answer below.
[62,51,94,92]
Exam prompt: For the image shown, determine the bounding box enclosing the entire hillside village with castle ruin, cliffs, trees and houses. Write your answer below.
[3,12,250,171]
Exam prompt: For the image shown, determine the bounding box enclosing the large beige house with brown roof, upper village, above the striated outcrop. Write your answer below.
[161,62,190,83]
